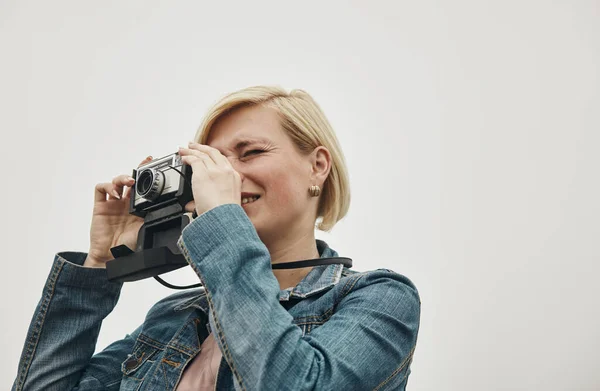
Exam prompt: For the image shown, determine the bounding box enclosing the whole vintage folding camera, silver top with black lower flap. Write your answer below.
[106,153,193,282]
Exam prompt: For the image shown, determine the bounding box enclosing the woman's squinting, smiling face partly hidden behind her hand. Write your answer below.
[207,106,321,243]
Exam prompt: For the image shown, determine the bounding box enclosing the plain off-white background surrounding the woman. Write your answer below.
[0,0,600,391]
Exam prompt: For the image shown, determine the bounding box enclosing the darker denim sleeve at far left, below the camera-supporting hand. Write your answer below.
[12,252,137,391]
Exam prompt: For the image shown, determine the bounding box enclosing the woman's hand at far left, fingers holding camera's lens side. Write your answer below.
[83,156,152,268]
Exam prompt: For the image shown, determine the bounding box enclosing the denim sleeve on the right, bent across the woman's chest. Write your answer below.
[178,204,420,390]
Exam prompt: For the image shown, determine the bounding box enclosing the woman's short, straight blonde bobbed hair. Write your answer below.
[194,86,350,231]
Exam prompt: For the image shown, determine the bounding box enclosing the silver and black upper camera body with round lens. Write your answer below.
[129,152,193,217]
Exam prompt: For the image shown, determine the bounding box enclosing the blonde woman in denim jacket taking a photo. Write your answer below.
[13,87,420,391]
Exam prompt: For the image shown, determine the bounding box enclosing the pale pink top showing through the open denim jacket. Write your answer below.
[176,333,223,391]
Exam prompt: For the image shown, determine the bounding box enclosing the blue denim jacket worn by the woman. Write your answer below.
[12,204,420,390]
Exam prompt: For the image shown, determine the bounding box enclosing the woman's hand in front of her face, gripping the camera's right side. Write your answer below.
[179,142,242,216]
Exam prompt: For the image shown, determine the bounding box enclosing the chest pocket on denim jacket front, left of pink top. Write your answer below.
[121,339,160,390]
